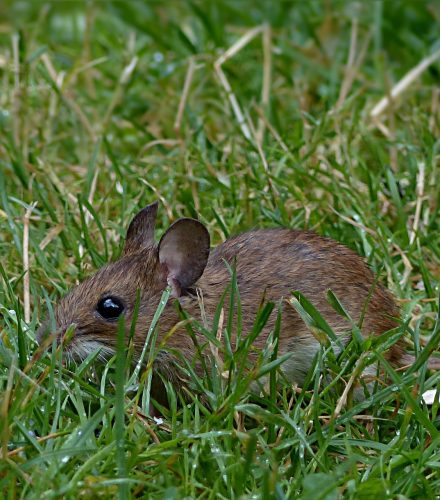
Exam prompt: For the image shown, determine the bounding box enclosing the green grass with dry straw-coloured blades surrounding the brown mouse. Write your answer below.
[0,0,440,499]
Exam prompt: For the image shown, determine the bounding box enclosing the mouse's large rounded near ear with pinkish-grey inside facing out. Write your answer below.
[158,219,209,297]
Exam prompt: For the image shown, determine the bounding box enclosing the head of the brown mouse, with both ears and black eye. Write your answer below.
[37,202,210,359]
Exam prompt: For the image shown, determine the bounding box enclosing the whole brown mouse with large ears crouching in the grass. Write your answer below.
[38,203,402,395]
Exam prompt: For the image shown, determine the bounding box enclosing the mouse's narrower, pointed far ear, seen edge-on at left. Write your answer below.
[123,201,159,255]
